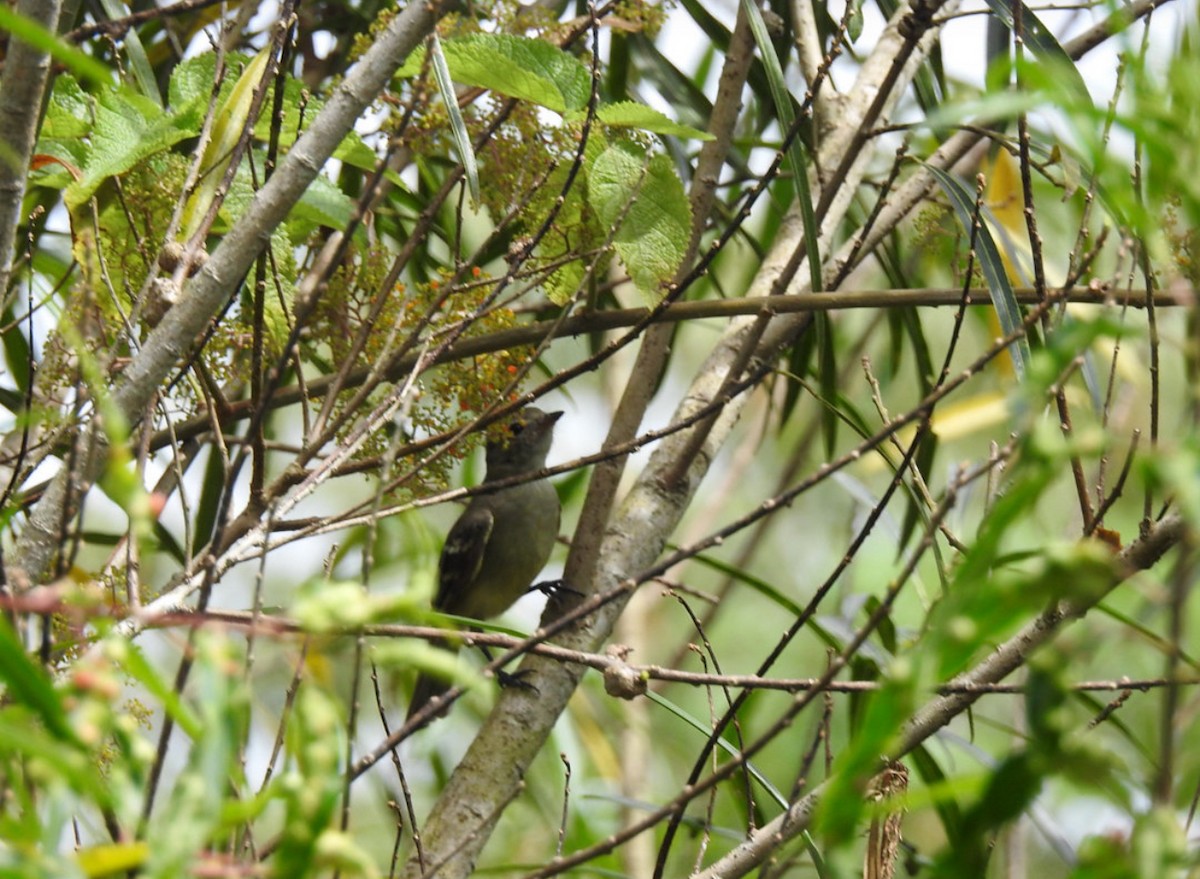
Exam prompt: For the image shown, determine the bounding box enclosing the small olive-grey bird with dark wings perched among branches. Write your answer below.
[408,406,563,718]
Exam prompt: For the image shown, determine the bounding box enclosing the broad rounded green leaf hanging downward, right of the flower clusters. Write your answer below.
[588,140,691,299]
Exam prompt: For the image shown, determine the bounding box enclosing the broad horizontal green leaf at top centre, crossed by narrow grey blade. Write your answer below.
[397,34,592,114]
